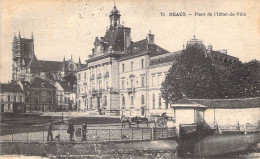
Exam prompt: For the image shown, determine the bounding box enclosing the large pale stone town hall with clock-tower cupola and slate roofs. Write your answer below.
[77,6,239,116]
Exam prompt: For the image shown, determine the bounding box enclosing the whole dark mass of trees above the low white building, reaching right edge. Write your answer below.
[161,44,260,103]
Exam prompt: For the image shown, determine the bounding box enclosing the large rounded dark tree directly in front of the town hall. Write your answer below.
[161,44,219,103]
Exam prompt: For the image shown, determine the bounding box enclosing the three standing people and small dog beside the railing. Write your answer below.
[47,123,87,141]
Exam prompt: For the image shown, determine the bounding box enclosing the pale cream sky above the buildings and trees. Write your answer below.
[0,0,260,82]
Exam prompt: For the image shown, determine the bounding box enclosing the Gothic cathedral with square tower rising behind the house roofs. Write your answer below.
[12,32,83,83]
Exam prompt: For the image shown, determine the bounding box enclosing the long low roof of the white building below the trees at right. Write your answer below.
[190,97,260,108]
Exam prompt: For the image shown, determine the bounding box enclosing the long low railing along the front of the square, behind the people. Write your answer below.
[0,127,176,142]
